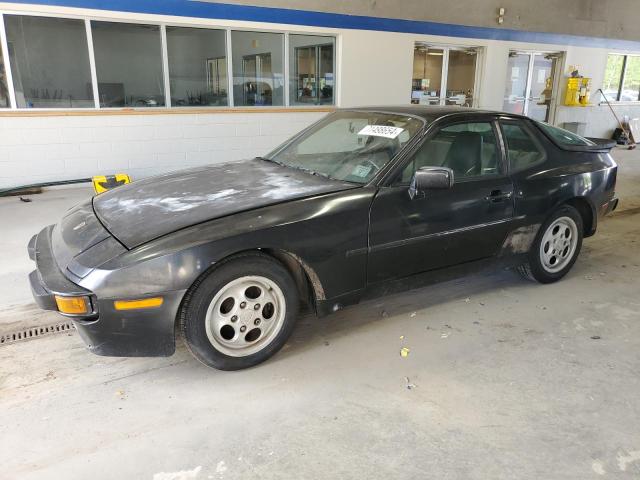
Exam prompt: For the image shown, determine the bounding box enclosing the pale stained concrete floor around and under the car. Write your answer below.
[0,151,640,480]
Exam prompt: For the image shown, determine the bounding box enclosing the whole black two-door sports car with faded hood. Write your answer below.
[29,106,617,370]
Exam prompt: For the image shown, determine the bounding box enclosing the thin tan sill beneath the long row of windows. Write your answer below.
[0,105,337,117]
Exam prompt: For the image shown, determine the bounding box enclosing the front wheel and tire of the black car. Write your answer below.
[180,253,300,370]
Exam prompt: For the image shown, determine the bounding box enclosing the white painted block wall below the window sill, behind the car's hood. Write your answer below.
[0,112,326,188]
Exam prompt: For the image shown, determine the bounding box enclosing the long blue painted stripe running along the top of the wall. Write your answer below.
[8,0,640,50]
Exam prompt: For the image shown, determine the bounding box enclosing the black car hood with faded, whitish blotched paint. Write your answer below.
[93,159,356,248]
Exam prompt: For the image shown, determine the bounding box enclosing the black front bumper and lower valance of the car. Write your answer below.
[27,225,185,357]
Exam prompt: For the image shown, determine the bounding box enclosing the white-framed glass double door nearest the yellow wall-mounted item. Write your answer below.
[502,50,562,122]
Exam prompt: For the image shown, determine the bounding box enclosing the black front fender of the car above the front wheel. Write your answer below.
[78,188,375,312]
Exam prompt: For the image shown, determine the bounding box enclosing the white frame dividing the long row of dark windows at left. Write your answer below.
[0,8,342,113]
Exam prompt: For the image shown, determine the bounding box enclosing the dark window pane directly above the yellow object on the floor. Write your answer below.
[91,21,165,107]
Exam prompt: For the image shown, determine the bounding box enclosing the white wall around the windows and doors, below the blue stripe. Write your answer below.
[0,3,640,188]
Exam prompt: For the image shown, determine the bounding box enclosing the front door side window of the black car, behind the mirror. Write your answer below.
[399,122,500,184]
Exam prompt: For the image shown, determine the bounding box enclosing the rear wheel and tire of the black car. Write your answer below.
[518,205,584,283]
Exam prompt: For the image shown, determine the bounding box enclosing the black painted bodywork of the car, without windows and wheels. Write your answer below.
[29,106,616,356]
